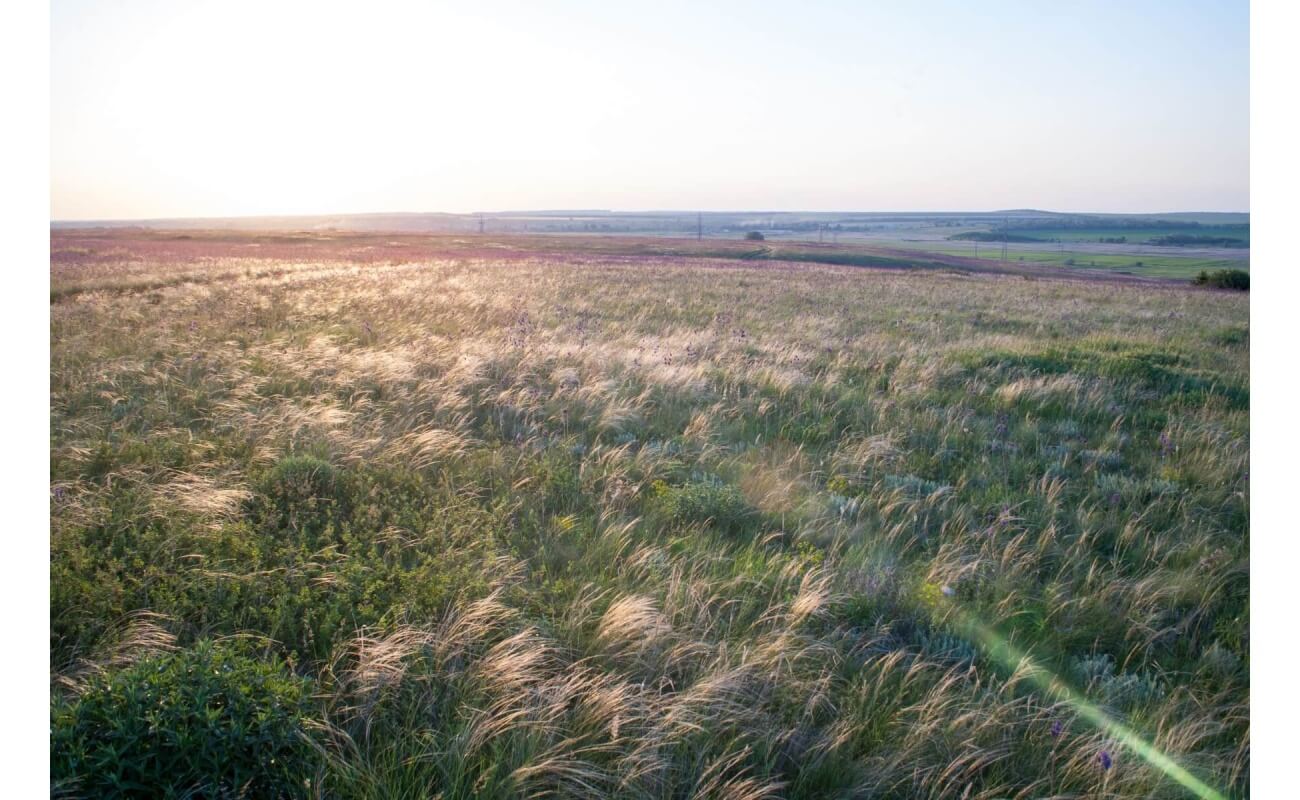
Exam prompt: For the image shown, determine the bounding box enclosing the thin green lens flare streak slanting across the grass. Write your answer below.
[953,609,1227,800]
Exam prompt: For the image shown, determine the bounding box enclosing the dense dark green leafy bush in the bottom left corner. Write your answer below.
[49,641,317,797]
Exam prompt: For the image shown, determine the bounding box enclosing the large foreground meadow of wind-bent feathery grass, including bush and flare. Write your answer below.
[49,233,1249,800]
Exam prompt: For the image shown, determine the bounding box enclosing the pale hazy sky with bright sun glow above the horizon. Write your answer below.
[51,0,1249,219]
